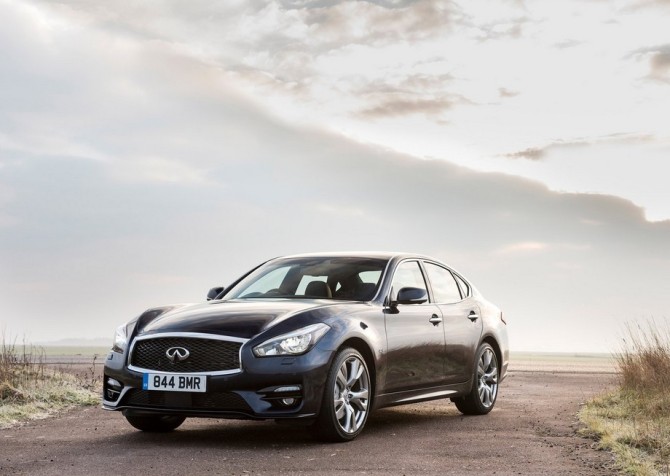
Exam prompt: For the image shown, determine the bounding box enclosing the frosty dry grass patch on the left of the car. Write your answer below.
[0,335,100,428]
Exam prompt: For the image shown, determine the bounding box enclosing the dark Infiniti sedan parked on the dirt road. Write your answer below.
[103,252,509,441]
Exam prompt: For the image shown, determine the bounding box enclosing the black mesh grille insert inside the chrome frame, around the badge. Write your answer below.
[130,337,242,373]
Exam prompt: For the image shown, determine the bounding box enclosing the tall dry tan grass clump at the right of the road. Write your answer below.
[580,321,670,475]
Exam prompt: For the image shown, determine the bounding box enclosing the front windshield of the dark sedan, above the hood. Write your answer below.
[224,257,387,301]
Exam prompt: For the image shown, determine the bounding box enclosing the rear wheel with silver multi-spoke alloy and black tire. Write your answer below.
[452,343,500,415]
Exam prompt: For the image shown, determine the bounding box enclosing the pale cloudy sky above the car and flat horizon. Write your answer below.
[0,0,670,352]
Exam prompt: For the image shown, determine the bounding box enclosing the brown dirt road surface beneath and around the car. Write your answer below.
[0,371,614,476]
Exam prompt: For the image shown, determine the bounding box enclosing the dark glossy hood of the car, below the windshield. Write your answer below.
[137,299,341,339]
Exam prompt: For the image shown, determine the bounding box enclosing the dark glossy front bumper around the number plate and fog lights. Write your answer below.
[102,346,333,419]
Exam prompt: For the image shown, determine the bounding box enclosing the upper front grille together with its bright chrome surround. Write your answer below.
[127,332,248,375]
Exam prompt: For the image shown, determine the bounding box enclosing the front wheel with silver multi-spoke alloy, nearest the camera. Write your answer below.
[312,348,371,442]
